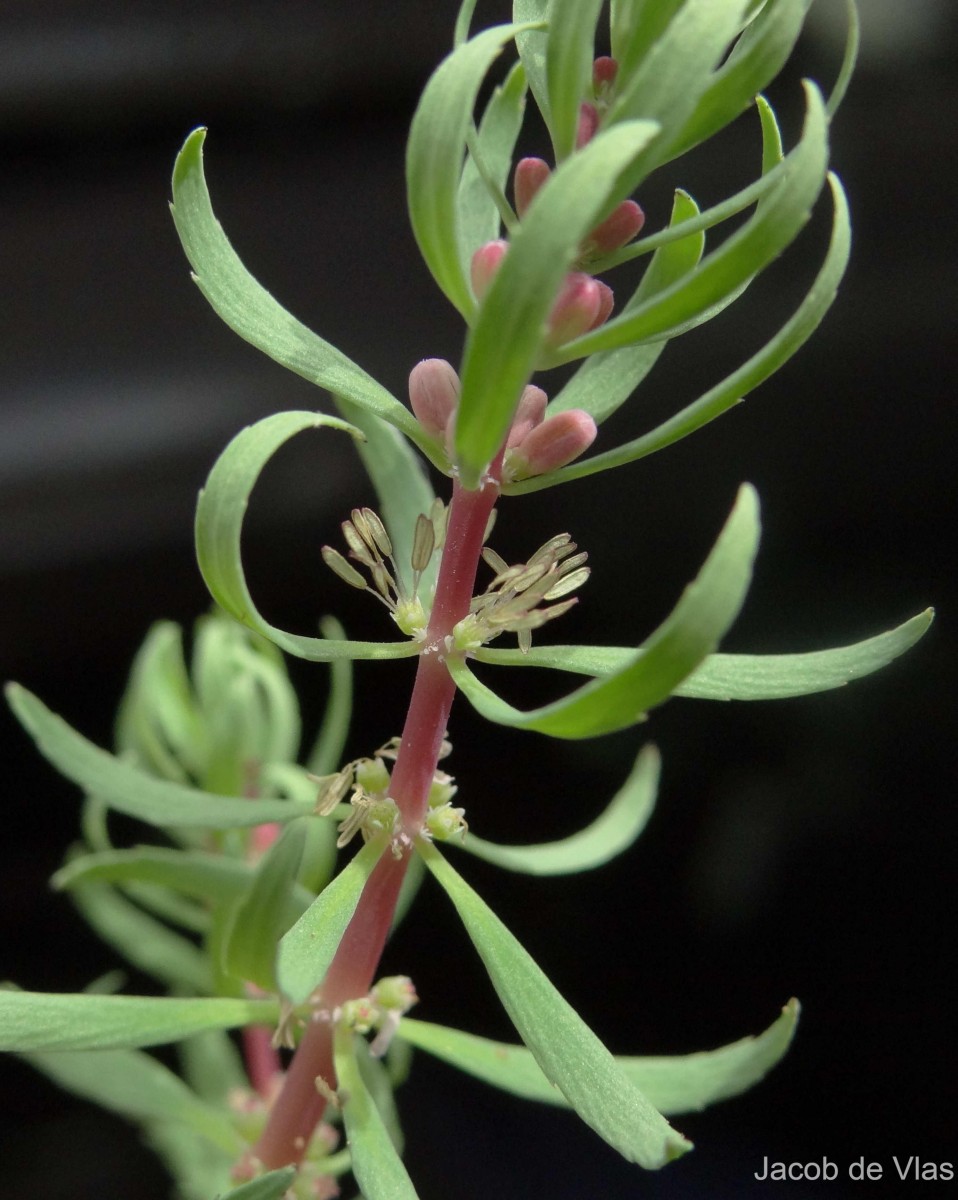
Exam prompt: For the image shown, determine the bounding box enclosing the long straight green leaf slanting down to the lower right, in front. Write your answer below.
[419,844,691,1169]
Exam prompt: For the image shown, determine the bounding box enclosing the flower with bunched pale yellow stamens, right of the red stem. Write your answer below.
[447,533,589,653]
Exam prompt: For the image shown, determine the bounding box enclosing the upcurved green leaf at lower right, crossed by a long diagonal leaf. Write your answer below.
[397,1000,798,1116]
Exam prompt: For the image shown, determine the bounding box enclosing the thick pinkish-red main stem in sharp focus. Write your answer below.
[253,468,502,1169]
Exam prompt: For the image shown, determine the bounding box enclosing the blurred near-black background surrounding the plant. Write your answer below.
[0,0,958,1200]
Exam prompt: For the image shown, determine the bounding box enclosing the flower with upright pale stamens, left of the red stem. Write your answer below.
[321,505,444,641]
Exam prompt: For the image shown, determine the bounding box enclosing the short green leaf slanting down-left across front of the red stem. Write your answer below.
[276,839,385,1004]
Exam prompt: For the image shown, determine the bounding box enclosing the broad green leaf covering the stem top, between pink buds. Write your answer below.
[455,121,657,487]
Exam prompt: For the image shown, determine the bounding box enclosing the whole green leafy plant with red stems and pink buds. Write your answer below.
[0,0,930,1200]
